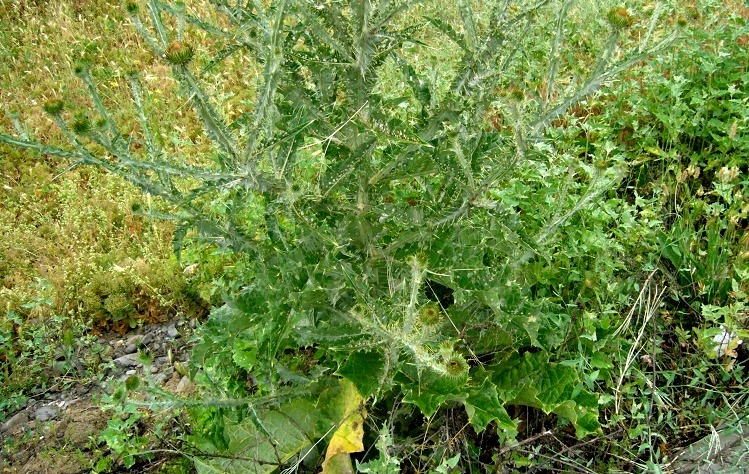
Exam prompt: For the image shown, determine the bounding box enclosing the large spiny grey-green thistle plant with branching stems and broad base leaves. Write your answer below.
[0,0,676,472]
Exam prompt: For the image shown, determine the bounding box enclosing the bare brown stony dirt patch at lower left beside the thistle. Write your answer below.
[0,320,195,474]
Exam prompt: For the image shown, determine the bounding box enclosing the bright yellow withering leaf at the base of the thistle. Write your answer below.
[322,379,365,474]
